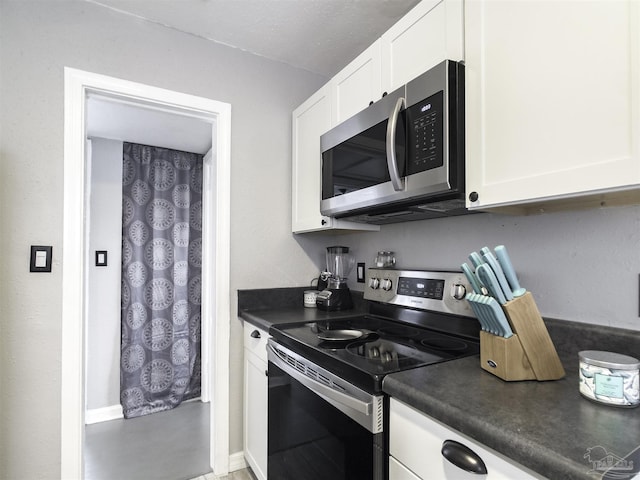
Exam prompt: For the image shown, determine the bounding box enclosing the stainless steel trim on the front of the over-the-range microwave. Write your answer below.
[320,61,464,216]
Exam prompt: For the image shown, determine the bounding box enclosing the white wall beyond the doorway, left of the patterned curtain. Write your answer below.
[85,138,122,410]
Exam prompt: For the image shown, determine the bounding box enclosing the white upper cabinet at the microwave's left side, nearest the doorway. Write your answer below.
[291,84,380,233]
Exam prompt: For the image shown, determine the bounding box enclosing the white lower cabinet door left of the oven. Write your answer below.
[244,323,269,480]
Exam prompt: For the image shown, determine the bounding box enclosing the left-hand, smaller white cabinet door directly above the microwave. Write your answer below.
[330,40,382,125]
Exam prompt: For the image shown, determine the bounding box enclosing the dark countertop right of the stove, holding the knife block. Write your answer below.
[383,320,640,480]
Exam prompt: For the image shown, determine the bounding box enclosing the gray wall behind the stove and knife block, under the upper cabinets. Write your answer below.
[338,207,640,332]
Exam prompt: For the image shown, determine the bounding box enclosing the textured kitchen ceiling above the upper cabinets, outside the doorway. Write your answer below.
[86,0,420,78]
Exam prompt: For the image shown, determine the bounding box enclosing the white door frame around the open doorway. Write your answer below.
[60,67,231,479]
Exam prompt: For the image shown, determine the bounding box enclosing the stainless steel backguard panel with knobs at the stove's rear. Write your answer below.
[364,268,475,318]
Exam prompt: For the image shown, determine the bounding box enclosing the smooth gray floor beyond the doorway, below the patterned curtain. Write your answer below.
[84,402,212,480]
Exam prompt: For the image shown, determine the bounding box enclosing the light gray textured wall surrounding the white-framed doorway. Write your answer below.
[0,0,326,479]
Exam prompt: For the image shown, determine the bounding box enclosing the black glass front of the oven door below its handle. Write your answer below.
[267,362,382,480]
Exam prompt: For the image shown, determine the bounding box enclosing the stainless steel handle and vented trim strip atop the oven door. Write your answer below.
[267,338,384,433]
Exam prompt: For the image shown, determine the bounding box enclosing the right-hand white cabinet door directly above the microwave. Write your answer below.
[382,0,464,92]
